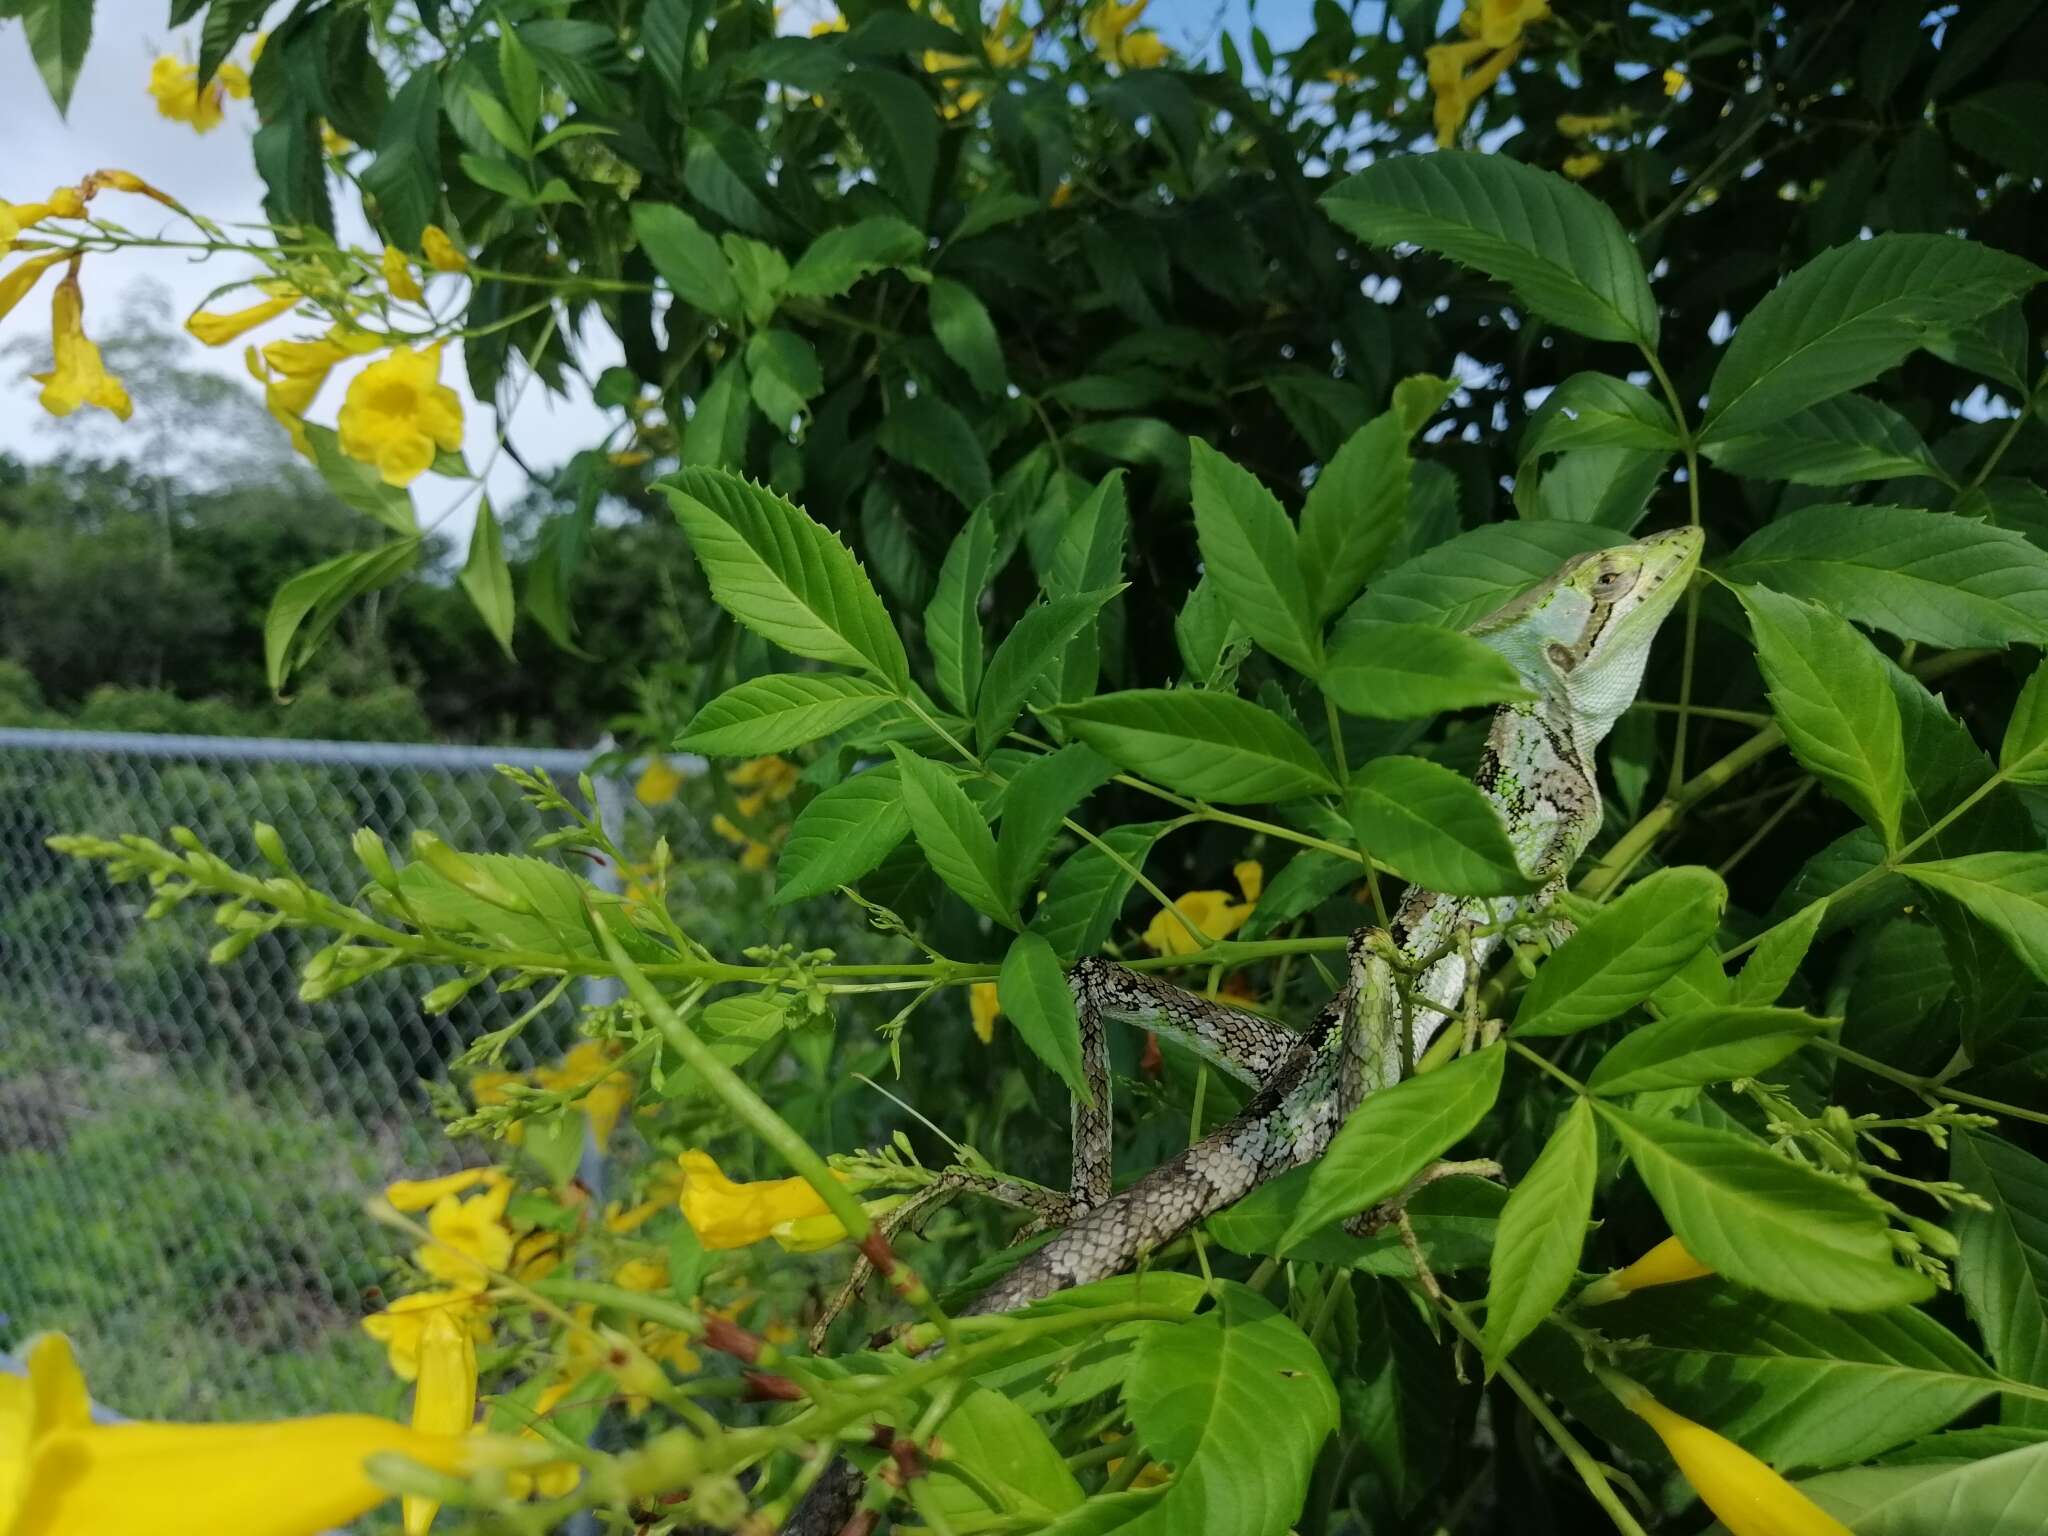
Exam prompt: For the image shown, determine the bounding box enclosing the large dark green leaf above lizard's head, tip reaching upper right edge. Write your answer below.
[1700,233,2042,442]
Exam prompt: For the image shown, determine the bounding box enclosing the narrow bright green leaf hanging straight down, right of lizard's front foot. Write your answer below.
[1487,1098,1599,1360]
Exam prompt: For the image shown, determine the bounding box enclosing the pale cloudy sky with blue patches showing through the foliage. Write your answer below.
[0,0,1335,539]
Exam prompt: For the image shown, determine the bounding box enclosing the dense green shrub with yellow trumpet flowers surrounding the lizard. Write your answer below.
[12,0,2048,1536]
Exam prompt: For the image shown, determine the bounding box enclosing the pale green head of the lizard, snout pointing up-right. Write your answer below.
[1470,528,1702,752]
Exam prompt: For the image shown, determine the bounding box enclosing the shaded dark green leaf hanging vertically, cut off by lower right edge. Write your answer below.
[1948,1130,2048,1430]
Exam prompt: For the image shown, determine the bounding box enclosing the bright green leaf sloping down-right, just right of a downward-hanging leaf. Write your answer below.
[1595,1102,1933,1313]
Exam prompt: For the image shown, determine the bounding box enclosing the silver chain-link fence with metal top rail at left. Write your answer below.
[0,729,679,1419]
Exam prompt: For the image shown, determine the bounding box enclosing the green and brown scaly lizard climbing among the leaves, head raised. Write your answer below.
[784,528,1702,1536]
